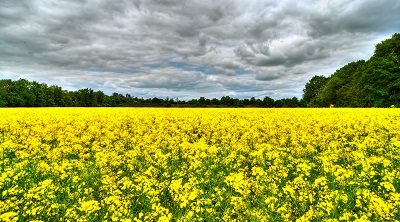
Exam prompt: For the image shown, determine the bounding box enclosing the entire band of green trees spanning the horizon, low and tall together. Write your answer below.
[0,33,400,108]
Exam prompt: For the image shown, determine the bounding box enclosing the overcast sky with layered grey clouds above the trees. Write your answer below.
[0,0,400,100]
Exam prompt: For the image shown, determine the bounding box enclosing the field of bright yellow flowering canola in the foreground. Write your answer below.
[0,108,400,221]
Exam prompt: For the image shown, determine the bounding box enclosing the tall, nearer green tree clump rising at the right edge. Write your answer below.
[302,33,400,107]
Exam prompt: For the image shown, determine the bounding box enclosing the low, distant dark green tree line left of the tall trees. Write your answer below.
[0,79,305,107]
